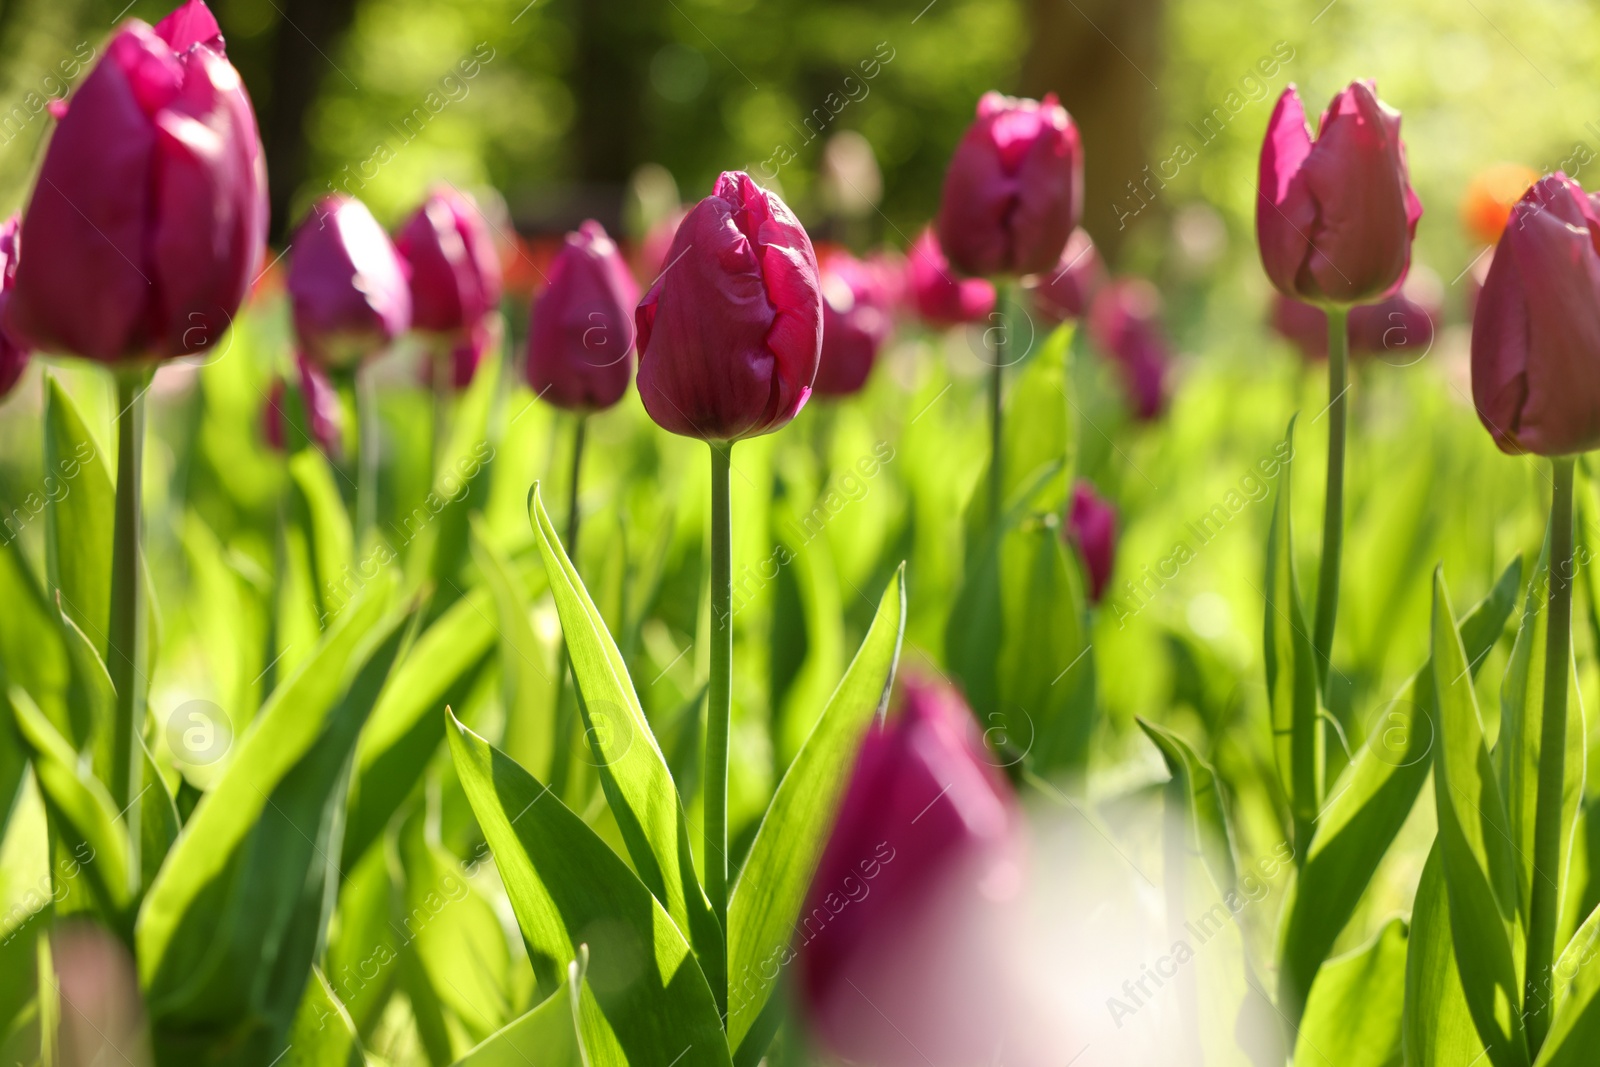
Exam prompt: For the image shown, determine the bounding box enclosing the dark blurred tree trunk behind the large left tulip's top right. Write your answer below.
[256,0,357,245]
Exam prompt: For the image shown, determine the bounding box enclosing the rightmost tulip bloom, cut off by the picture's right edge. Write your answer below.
[1472,173,1600,456]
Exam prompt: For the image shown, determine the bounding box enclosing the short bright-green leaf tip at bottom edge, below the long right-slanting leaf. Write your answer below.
[1294,918,1406,1067]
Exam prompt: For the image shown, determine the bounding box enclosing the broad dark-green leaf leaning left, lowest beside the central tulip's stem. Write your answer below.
[445,712,730,1067]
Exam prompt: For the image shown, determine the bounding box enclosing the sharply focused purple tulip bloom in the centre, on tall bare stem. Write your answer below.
[635,171,822,442]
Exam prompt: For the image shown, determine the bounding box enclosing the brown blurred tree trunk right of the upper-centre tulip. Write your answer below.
[1022,0,1165,264]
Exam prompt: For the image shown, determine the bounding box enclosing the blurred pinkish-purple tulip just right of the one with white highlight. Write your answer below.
[395,186,501,341]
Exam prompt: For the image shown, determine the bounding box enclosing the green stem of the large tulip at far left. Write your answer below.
[107,366,150,872]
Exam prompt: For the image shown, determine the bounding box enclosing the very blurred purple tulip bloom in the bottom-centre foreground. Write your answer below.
[795,683,1022,1067]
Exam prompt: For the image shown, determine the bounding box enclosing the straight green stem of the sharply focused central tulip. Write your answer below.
[704,442,733,1019]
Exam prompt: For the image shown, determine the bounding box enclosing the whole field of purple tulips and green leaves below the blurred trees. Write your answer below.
[0,0,1600,1067]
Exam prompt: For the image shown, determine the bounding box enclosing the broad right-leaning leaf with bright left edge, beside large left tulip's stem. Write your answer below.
[136,581,411,1062]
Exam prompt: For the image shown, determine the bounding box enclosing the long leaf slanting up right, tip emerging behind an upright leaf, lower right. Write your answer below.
[1278,557,1522,1017]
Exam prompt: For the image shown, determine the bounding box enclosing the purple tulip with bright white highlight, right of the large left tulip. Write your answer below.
[288,195,411,371]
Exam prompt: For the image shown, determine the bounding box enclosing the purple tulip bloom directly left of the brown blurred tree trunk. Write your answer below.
[939,93,1083,277]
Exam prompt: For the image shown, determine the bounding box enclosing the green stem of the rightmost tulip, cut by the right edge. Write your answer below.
[1523,456,1574,1053]
